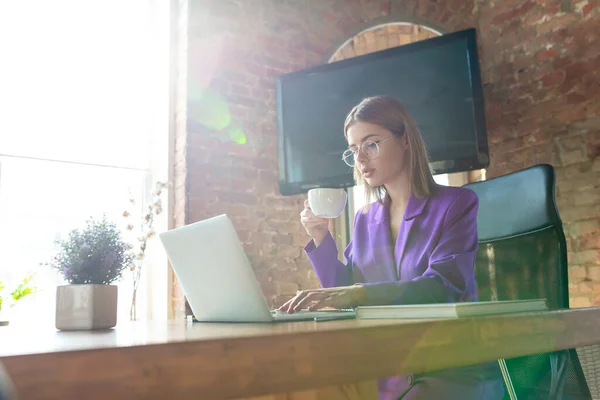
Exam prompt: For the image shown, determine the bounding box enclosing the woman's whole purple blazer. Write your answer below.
[305,186,501,399]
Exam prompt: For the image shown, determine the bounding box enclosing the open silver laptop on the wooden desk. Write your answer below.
[158,214,356,322]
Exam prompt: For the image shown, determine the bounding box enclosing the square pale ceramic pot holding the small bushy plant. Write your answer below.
[56,284,118,330]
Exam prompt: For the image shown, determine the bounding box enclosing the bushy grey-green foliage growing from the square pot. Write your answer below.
[46,216,133,285]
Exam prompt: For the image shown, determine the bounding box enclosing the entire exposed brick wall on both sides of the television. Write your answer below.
[177,0,600,312]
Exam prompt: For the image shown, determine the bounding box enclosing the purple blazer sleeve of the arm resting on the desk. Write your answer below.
[363,190,479,304]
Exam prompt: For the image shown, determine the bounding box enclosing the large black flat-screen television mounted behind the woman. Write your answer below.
[276,29,489,195]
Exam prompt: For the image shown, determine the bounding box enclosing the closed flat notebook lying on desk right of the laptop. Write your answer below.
[355,299,548,319]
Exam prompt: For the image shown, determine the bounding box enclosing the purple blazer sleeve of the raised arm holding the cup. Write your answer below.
[304,233,352,288]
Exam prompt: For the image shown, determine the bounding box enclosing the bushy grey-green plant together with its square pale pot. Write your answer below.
[48,216,132,330]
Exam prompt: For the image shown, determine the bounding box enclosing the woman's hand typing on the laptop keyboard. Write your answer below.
[279,285,365,313]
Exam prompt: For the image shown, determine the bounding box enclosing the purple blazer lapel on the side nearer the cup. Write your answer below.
[368,204,398,280]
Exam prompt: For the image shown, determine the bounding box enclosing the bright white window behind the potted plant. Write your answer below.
[0,0,169,322]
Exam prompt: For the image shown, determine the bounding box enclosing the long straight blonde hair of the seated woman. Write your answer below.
[344,96,436,211]
